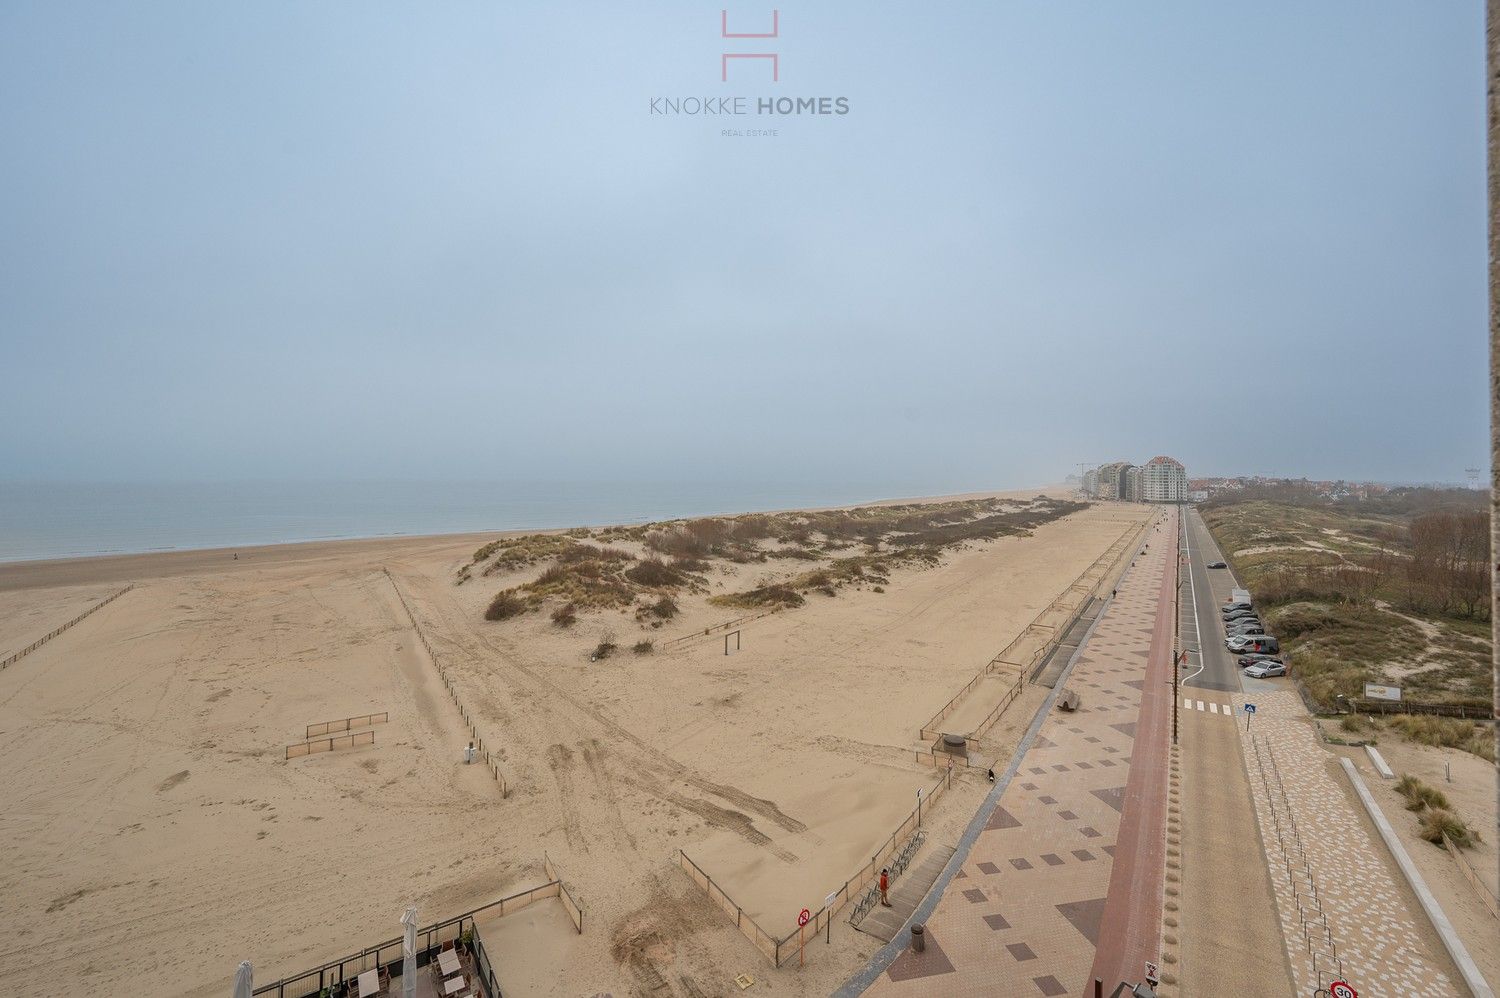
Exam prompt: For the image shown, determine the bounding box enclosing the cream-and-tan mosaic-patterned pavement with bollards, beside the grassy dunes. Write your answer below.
[1235,690,1460,998]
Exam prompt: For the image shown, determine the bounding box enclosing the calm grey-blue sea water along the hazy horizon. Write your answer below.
[0,482,1002,561]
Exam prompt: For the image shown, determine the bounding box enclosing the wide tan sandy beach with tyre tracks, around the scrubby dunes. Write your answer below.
[0,491,1151,995]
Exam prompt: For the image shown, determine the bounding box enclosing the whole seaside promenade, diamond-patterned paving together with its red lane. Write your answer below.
[867,518,1170,998]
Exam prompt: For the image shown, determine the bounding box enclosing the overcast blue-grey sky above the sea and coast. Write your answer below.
[0,0,1488,488]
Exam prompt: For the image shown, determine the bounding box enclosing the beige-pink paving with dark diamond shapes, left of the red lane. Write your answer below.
[867,516,1175,998]
